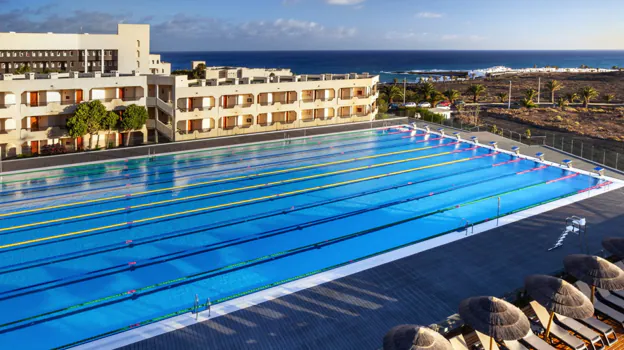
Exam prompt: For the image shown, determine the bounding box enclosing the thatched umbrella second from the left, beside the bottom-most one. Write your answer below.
[459,297,531,350]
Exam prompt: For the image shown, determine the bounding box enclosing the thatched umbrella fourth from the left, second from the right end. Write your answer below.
[563,254,624,304]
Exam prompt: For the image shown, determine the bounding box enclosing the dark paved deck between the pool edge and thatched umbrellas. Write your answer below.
[121,188,624,350]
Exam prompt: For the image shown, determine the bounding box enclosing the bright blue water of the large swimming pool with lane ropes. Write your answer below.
[0,128,603,349]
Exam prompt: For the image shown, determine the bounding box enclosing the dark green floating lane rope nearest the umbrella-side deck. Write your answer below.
[0,170,577,334]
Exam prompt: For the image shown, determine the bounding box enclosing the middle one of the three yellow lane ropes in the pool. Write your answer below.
[0,143,464,232]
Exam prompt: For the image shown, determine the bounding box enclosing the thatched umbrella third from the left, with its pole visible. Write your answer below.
[524,275,594,341]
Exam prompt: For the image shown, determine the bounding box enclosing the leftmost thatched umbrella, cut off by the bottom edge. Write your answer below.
[384,324,453,350]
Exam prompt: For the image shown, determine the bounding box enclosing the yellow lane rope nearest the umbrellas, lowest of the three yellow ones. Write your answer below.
[0,158,471,249]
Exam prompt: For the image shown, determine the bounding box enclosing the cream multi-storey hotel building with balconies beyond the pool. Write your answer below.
[0,24,379,158]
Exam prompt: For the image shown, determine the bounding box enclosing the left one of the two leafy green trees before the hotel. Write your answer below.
[67,100,107,149]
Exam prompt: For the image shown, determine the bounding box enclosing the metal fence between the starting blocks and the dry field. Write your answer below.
[382,112,624,171]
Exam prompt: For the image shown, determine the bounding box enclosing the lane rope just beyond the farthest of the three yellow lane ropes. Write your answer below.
[0,138,434,206]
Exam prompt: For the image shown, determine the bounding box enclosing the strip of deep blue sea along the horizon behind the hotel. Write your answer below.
[160,51,624,81]
